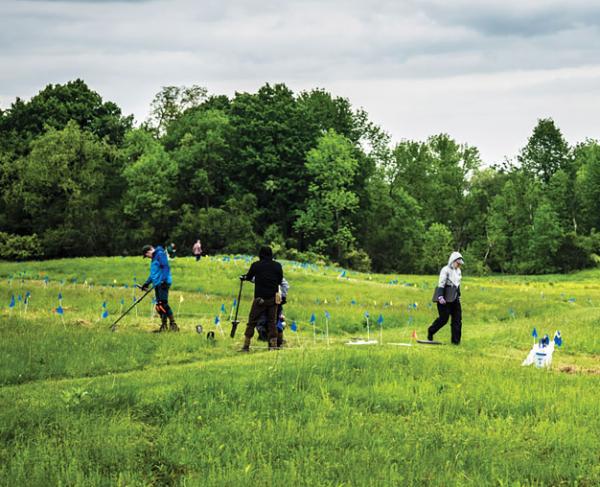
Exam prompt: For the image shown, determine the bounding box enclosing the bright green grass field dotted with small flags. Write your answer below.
[0,256,600,486]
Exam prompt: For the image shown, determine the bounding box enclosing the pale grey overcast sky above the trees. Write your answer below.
[0,0,600,164]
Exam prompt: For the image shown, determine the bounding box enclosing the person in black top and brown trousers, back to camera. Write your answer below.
[240,247,283,352]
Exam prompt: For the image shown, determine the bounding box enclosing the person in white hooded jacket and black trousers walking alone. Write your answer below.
[427,252,464,345]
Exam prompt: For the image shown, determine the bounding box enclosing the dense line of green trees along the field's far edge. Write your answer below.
[0,80,600,274]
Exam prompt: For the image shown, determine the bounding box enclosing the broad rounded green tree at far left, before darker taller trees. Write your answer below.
[5,121,118,256]
